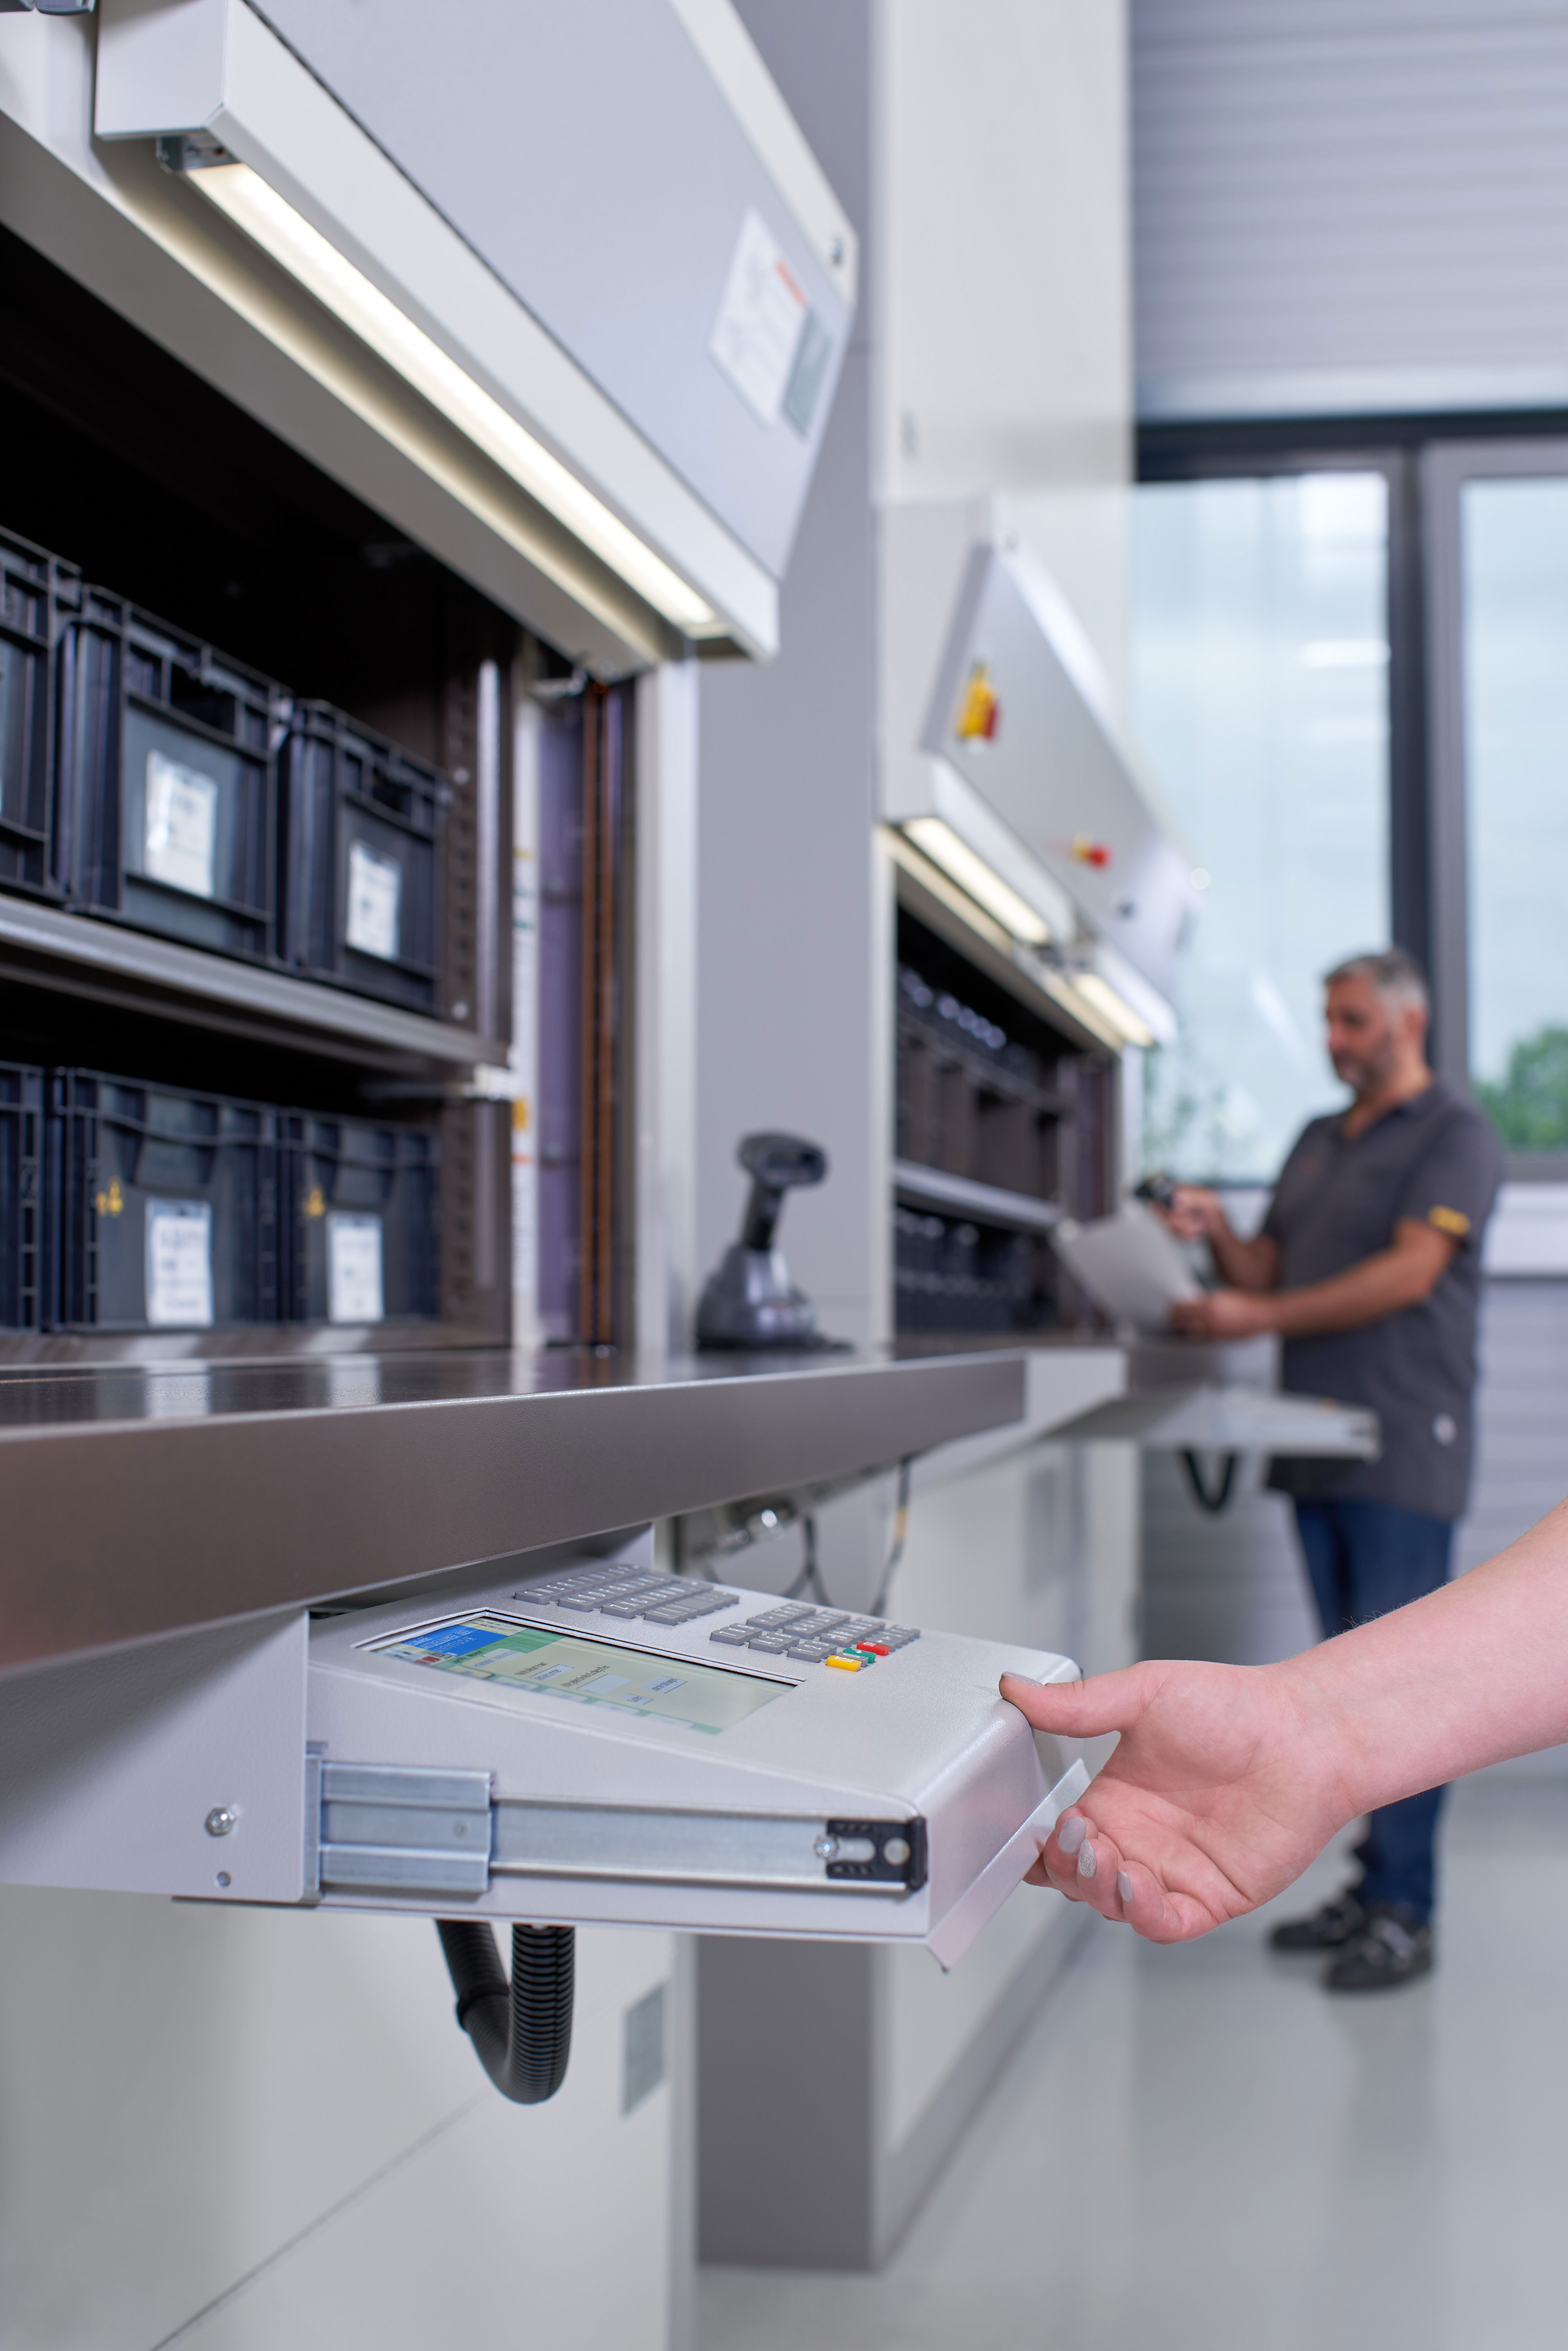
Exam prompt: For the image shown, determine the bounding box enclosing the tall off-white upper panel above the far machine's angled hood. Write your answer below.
[875,0,1131,715]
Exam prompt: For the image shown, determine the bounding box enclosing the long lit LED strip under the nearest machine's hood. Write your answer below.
[188,162,726,637]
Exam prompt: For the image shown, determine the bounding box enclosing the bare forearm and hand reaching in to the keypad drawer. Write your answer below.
[1001,1502,1568,1942]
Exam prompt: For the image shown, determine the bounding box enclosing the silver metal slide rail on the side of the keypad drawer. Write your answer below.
[306,1749,926,1902]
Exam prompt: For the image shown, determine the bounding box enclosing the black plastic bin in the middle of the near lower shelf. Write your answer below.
[47,1070,277,1331]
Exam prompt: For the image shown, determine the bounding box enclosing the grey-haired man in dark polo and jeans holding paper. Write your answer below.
[1168,950,1502,1991]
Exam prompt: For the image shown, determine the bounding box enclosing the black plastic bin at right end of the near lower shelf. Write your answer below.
[280,1110,440,1324]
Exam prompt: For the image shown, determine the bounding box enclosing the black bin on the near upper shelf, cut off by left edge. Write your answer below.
[0,531,80,898]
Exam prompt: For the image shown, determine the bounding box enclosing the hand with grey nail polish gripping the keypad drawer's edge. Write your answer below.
[1001,1662,1356,1942]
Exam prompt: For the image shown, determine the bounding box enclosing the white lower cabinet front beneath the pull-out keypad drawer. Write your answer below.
[0,1888,684,2351]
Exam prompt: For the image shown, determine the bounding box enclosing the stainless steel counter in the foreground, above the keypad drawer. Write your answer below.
[0,1349,1025,1669]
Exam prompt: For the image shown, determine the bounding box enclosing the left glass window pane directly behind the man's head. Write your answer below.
[1133,463,1392,1185]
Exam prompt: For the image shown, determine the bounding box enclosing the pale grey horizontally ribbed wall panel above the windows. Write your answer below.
[1133,0,1568,416]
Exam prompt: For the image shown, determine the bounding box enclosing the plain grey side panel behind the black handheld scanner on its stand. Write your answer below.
[696,0,891,1342]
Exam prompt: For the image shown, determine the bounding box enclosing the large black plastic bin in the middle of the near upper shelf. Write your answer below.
[54,588,282,962]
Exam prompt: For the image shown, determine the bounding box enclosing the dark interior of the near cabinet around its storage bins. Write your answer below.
[0,230,569,1338]
